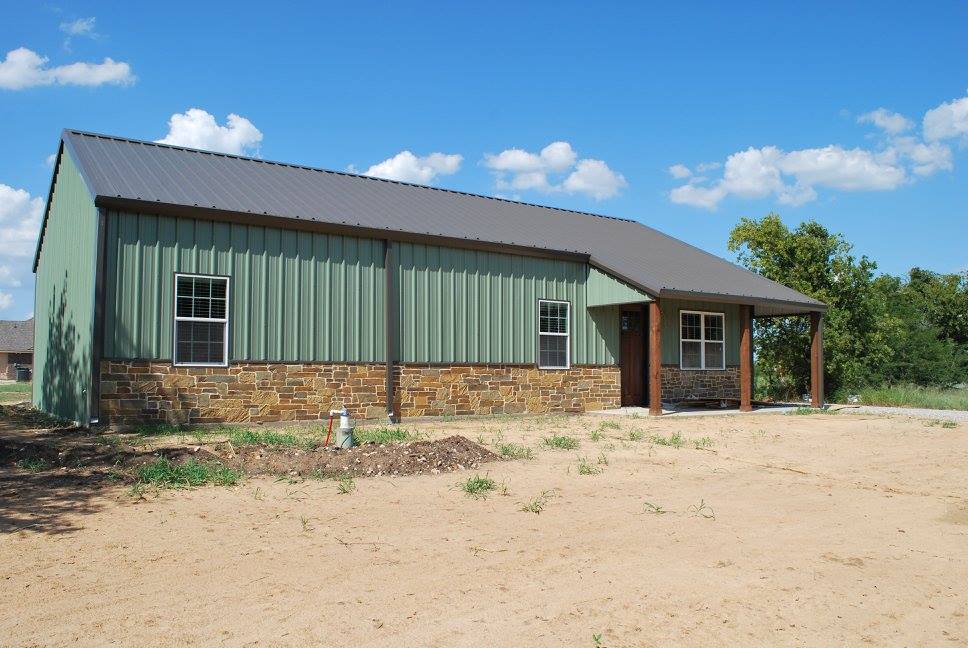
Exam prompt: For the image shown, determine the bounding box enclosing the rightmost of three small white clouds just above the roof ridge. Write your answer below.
[484,141,628,200]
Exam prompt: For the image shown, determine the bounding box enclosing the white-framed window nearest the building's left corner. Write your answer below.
[172,273,229,367]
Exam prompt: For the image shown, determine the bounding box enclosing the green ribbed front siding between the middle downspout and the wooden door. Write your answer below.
[397,243,618,364]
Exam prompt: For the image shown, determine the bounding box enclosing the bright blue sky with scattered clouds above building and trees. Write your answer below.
[0,2,968,319]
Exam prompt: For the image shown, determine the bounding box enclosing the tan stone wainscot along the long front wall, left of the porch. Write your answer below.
[100,360,621,425]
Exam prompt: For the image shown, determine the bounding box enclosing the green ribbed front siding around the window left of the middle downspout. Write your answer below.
[104,212,385,362]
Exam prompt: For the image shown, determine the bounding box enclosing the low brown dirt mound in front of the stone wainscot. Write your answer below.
[222,436,500,477]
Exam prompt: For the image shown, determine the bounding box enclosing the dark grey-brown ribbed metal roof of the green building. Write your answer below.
[41,130,825,315]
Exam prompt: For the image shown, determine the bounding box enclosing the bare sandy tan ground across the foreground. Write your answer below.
[0,414,968,647]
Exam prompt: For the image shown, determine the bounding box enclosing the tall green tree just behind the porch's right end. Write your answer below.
[729,213,892,398]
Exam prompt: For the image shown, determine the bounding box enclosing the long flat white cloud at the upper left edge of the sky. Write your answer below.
[0,47,135,90]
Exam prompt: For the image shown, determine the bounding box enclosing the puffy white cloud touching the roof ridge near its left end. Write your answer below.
[155,108,262,155]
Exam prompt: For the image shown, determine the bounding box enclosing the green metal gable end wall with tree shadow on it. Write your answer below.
[32,151,97,424]
